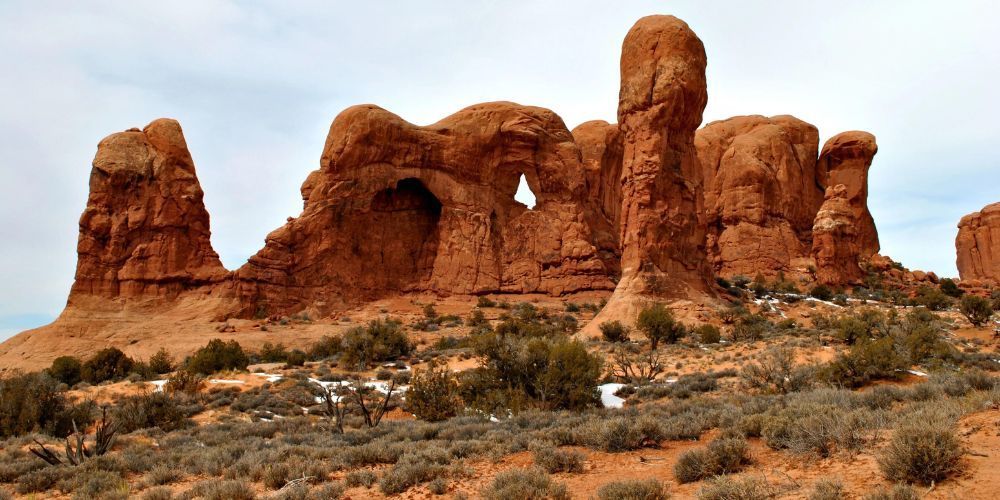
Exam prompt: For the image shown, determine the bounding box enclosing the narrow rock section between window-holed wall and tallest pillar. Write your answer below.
[573,120,622,275]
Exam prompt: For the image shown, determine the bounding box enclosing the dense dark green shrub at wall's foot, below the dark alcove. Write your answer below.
[341,318,412,368]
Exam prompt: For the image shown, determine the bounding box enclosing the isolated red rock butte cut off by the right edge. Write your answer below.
[955,203,1000,283]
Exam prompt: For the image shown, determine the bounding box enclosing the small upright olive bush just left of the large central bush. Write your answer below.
[405,364,464,422]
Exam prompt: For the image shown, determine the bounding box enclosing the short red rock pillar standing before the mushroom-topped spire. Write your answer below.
[812,184,864,285]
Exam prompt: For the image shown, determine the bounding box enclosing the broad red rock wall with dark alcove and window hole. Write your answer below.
[235,102,613,314]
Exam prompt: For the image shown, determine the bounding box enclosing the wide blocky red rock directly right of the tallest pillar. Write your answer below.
[695,116,823,277]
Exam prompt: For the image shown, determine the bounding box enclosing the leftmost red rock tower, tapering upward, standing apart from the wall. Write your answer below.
[69,119,226,304]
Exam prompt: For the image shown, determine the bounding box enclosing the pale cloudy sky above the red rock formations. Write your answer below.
[0,0,1000,339]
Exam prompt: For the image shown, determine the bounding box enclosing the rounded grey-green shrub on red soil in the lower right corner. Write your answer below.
[878,422,962,484]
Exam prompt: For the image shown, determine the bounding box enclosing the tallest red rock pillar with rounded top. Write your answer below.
[589,16,712,333]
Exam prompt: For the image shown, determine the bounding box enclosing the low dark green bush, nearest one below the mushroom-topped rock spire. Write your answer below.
[819,338,908,388]
